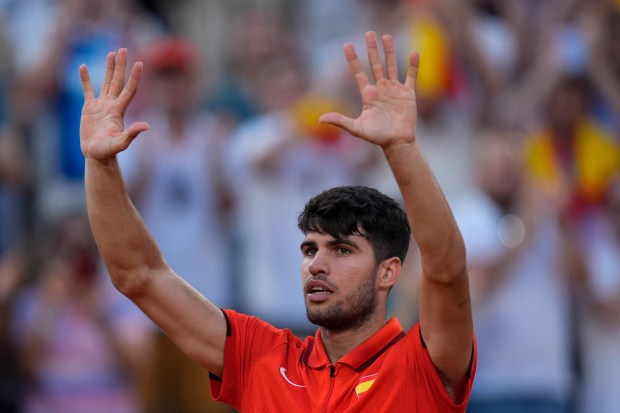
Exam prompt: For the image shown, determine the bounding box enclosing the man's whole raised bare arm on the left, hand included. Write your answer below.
[80,49,226,375]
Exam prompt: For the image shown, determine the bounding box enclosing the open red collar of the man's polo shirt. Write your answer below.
[305,317,405,371]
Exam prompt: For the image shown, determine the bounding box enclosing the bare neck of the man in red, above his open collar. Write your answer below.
[321,312,386,364]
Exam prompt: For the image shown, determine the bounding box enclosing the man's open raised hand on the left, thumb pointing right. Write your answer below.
[80,49,149,161]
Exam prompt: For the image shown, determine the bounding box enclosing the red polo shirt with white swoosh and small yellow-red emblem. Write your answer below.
[211,310,476,413]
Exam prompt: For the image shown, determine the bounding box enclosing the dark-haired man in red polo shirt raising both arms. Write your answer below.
[80,32,475,412]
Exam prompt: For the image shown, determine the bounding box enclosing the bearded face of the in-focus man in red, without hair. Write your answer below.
[301,232,378,331]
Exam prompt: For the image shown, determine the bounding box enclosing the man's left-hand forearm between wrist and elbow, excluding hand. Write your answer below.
[86,158,166,292]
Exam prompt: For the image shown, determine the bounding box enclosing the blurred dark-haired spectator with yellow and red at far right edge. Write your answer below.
[527,76,620,222]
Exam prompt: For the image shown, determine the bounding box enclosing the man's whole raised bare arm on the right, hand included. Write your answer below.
[320,33,473,400]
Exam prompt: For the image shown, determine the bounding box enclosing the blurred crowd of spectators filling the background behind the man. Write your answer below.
[0,0,620,413]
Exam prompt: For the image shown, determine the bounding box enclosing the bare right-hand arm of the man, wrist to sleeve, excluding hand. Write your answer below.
[384,142,473,392]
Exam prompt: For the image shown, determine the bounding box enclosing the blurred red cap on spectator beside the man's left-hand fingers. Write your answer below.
[144,36,200,73]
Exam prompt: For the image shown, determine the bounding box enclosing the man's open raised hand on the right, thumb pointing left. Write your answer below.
[319,32,419,148]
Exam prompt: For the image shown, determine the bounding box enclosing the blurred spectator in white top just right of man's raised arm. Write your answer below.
[454,128,574,413]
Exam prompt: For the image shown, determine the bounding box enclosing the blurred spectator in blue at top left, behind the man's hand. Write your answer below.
[14,0,160,219]
